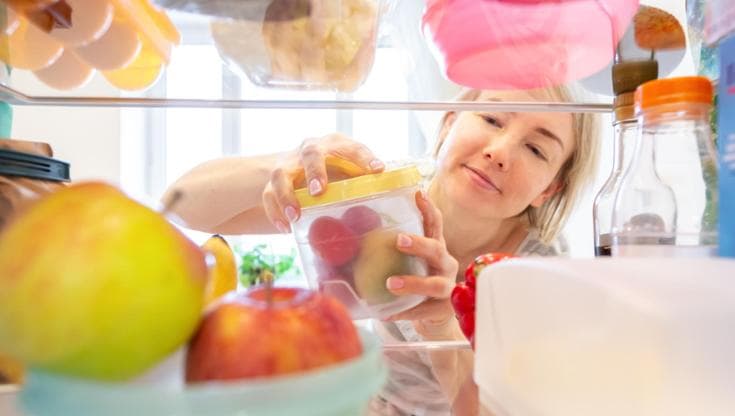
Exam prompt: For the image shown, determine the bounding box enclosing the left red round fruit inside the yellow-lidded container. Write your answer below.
[309,217,360,267]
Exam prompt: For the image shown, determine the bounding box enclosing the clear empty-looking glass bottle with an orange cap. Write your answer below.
[612,77,717,257]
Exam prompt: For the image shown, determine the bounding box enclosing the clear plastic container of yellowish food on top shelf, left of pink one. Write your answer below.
[211,0,382,91]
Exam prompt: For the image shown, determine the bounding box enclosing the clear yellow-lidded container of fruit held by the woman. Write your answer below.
[293,159,426,319]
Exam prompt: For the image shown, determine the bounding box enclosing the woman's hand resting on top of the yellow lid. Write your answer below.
[263,133,385,233]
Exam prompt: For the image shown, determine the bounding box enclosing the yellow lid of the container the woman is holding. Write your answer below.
[296,162,421,208]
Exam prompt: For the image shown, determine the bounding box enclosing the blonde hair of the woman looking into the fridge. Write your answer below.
[434,86,600,243]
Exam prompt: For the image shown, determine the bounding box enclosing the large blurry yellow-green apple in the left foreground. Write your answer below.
[0,182,207,380]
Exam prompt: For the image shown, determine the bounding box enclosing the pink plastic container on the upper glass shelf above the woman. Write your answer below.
[422,0,638,89]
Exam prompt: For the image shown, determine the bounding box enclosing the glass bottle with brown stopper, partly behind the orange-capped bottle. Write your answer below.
[592,60,658,256]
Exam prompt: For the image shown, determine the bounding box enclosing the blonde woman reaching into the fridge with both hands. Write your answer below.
[165,87,598,415]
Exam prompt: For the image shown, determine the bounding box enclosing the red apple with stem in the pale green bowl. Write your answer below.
[186,286,362,383]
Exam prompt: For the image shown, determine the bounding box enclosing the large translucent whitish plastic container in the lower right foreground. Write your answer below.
[475,258,735,416]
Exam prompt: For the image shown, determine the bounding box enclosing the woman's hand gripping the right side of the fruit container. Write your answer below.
[386,192,459,338]
